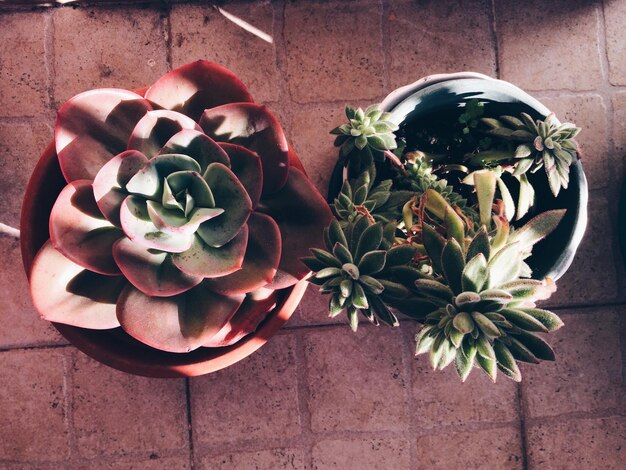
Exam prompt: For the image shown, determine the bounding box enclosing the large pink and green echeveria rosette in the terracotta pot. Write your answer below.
[30,61,331,352]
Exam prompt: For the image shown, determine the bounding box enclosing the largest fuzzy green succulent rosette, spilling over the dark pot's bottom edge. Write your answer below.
[415,180,564,381]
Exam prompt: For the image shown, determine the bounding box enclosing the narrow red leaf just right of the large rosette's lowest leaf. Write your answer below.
[204,293,277,348]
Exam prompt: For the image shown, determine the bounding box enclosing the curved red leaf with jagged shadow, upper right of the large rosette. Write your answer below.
[200,103,289,194]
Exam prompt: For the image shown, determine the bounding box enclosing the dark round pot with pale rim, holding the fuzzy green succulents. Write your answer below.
[328,72,588,280]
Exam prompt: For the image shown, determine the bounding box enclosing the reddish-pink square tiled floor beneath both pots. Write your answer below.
[0,0,626,469]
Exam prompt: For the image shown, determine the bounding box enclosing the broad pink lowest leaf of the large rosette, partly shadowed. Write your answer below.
[117,284,245,353]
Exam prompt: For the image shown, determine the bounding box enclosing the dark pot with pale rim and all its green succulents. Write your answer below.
[305,73,587,381]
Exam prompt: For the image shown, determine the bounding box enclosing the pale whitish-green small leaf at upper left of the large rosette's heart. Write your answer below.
[126,154,200,201]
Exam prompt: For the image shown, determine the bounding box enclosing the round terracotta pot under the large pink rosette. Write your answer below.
[20,144,307,377]
